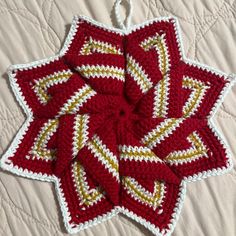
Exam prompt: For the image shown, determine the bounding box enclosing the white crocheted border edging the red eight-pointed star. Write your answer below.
[0,16,235,236]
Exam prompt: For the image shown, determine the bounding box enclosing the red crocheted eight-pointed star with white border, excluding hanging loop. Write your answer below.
[1,16,232,235]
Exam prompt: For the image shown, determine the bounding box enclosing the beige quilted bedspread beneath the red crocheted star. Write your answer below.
[0,0,236,236]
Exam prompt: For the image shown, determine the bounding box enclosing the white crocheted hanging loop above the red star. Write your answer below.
[114,0,133,30]
